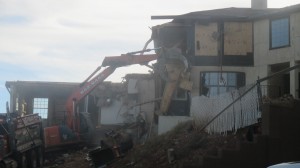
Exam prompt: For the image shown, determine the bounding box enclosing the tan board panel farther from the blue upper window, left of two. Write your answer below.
[195,23,219,56]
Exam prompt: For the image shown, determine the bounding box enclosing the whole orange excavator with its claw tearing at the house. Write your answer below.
[44,48,191,150]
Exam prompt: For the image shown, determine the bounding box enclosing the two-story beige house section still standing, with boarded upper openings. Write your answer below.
[152,0,300,98]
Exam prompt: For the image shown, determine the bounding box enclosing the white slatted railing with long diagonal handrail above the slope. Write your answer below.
[192,65,300,134]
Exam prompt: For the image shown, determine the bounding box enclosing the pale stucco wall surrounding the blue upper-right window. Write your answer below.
[254,12,300,97]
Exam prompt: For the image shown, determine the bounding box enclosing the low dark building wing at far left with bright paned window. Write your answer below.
[6,81,105,127]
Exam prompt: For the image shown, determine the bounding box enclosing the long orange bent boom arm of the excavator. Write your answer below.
[66,51,158,131]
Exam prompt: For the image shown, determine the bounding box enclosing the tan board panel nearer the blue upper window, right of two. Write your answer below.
[224,22,253,55]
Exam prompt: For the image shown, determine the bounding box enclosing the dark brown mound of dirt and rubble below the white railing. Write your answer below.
[108,122,238,168]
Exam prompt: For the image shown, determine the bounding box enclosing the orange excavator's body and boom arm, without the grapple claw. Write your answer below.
[44,51,158,148]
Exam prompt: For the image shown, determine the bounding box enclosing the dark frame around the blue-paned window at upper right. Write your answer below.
[269,16,291,50]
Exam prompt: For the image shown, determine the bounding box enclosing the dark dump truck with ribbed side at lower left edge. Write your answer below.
[0,104,44,168]
